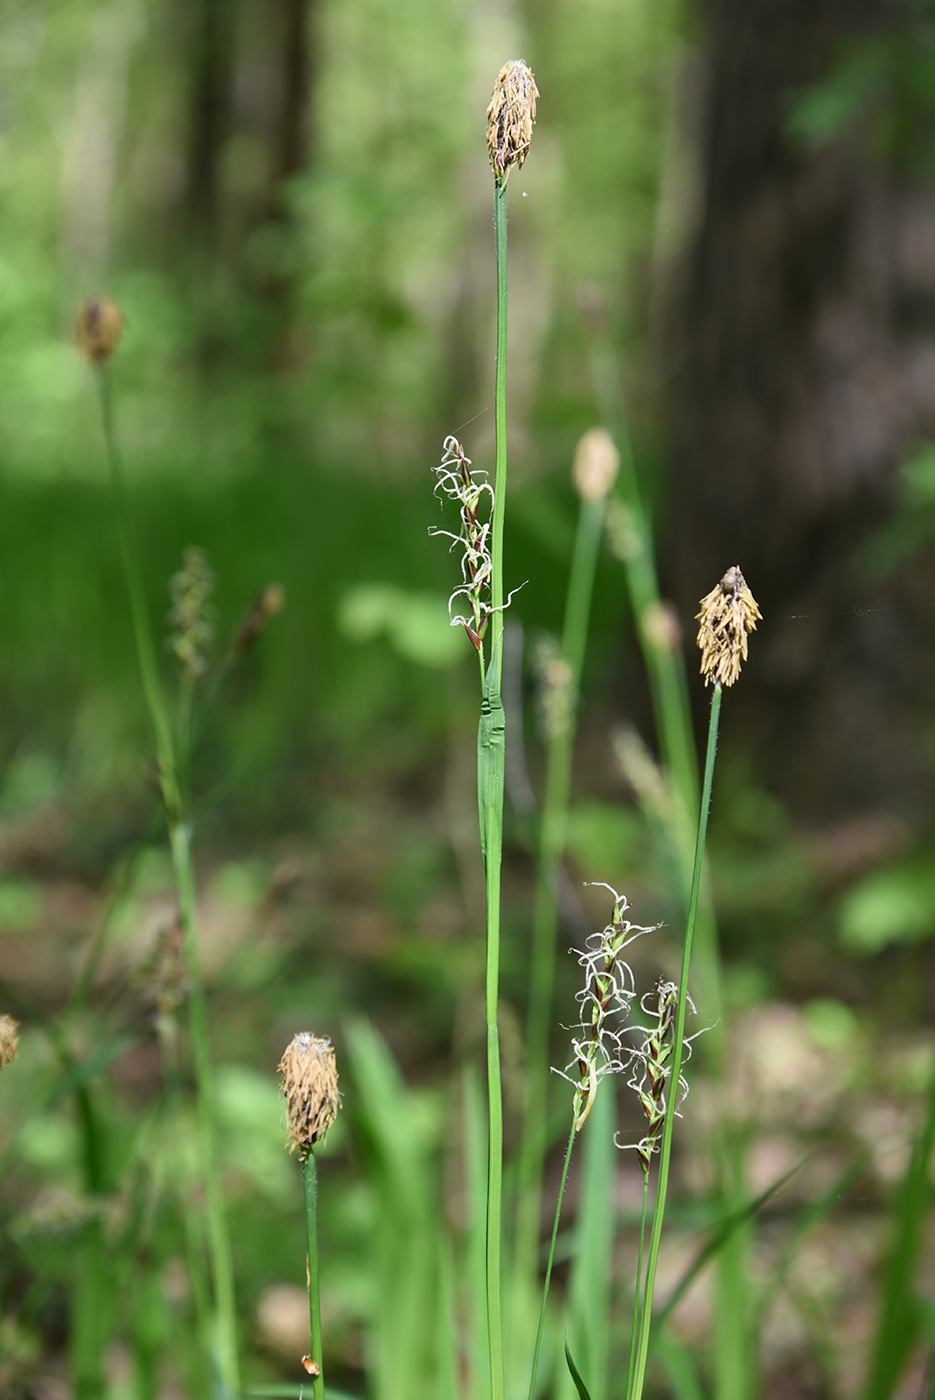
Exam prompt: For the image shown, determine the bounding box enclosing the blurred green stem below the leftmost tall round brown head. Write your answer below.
[97,364,239,1400]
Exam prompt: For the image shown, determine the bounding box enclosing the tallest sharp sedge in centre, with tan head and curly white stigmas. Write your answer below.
[437,59,539,1400]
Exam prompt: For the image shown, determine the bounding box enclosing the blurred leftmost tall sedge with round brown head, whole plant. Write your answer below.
[76,297,239,1400]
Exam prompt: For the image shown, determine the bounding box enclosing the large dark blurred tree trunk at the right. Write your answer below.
[668,0,935,844]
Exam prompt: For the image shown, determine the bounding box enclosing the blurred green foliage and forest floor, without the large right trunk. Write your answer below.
[0,0,935,1400]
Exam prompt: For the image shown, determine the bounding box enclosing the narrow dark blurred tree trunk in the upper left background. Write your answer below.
[180,0,318,370]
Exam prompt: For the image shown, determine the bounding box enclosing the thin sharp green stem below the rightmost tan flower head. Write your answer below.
[627,685,721,1400]
